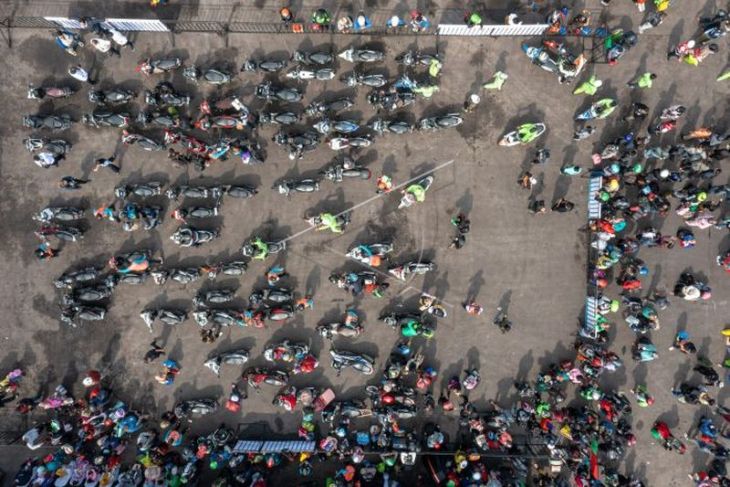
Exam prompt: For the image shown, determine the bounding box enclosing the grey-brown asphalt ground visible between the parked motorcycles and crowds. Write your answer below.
[0,2,730,485]
